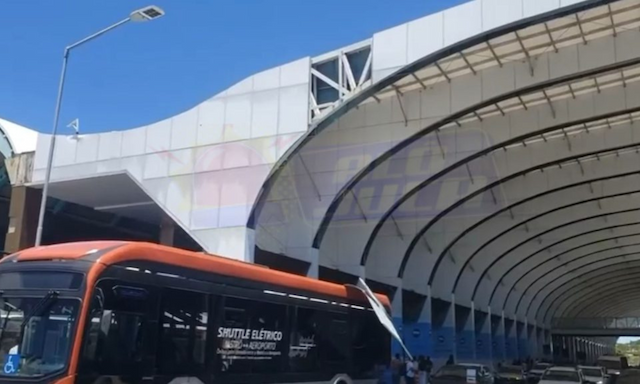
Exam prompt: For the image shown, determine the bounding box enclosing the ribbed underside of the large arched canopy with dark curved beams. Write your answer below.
[248,0,640,327]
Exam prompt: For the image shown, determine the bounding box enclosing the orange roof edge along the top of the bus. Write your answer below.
[8,241,390,308]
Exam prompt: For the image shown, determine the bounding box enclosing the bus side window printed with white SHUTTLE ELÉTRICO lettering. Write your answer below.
[216,297,287,374]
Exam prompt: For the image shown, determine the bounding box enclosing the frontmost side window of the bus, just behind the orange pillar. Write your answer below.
[81,279,157,376]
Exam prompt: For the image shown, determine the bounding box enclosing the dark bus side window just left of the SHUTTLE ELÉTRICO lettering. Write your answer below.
[157,289,209,375]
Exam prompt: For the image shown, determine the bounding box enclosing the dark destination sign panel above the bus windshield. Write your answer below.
[0,271,84,290]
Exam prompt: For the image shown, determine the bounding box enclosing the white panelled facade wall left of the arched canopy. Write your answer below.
[33,58,310,261]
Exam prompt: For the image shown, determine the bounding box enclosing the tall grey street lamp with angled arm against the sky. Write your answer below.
[35,5,164,246]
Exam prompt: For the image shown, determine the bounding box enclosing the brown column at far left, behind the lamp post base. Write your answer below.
[4,186,40,253]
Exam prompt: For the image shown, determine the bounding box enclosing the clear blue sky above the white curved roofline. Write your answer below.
[0,0,465,133]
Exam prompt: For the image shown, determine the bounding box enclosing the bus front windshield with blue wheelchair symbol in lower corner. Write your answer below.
[0,294,79,377]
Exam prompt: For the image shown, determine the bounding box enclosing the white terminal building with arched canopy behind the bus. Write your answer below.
[0,0,640,361]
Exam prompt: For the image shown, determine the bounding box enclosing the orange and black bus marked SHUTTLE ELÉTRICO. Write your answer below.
[0,241,391,384]
